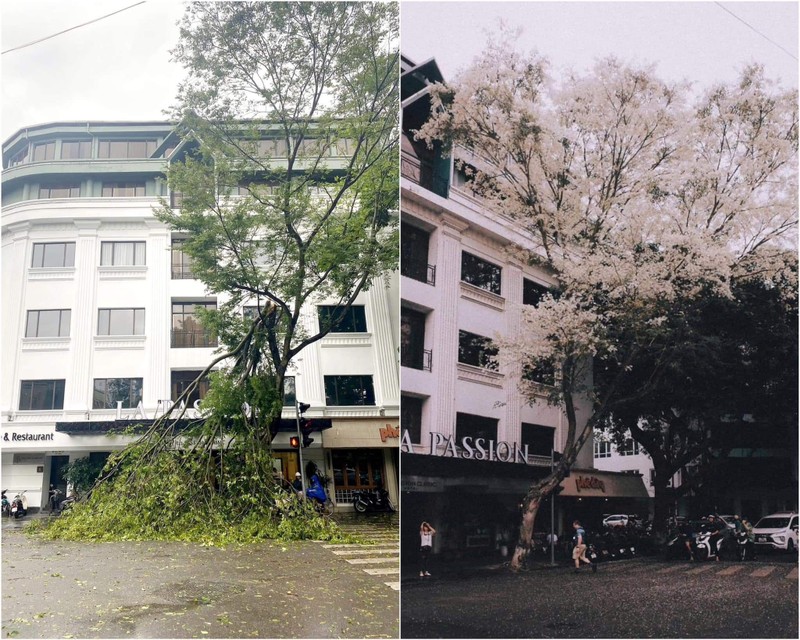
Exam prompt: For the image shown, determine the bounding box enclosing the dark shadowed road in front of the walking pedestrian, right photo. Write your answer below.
[400,555,798,638]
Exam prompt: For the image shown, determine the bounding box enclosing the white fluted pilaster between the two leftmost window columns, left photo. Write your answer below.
[64,220,100,411]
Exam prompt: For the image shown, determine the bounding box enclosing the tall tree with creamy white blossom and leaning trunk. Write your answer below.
[417,34,798,568]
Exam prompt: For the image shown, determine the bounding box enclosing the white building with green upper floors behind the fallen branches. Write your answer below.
[0,122,400,507]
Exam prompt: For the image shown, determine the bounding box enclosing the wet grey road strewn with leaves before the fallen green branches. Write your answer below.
[2,524,399,638]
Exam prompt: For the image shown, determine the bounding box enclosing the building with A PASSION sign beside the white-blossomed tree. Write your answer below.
[400,59,638,556]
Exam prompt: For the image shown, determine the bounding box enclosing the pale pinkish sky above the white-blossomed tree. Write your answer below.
[401,1,798,88]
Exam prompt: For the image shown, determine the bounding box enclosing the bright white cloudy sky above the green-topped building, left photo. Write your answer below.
[0,0,183,140]
